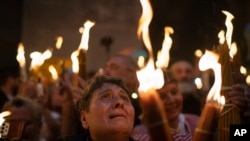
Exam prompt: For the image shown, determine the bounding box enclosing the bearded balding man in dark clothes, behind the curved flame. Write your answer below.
[169,60,206,115]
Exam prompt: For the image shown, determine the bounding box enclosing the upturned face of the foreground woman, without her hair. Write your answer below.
[81,83,135,138]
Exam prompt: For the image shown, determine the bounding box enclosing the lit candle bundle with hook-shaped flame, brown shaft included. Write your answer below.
[192,50,225,141]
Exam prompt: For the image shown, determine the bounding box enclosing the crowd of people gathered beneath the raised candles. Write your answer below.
[0,54,250,141]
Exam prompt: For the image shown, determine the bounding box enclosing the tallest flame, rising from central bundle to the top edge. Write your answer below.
[137,0,164,92]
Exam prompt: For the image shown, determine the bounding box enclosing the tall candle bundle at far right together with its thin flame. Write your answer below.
[216,11,241,141]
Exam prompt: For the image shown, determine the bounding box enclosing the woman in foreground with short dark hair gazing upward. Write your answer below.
[58,75,135,141]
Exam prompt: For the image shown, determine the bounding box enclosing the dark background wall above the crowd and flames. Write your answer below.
[0,0,250,72]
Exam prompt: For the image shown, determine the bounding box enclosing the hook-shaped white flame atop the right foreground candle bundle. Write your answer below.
[199,50,224,104]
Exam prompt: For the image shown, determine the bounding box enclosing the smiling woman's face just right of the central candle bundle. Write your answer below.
[158,83,183,121]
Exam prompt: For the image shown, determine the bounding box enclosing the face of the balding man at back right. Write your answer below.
[171,61,194,82]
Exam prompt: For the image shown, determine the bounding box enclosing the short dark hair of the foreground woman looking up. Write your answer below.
[77,75,129,112]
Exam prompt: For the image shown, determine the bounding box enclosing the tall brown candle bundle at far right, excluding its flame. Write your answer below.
[214,40,241,141]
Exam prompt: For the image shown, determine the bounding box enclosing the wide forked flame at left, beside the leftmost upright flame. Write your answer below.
[30,49,52,69]
